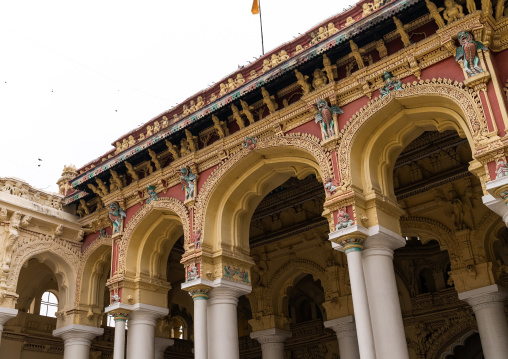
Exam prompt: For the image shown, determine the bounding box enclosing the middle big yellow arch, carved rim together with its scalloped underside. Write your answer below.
[193,133,334,255]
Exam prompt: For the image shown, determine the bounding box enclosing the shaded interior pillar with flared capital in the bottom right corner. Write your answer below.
[459,284,508,359]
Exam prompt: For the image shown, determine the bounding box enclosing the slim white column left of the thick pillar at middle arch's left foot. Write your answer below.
[189,287,210,359]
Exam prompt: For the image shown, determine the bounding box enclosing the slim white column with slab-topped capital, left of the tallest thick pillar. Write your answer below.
[329,225,376,359]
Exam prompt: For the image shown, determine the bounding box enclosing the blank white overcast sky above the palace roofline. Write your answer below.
[0,0,356,192]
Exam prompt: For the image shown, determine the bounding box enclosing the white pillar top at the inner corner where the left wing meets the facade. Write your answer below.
[53,324,104,359]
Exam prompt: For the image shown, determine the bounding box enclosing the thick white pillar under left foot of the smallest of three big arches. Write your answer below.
[127,303,169,359]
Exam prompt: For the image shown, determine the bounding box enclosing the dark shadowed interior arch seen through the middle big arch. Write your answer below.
[266,259,334,320]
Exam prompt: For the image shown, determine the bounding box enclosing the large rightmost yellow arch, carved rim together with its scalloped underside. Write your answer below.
[338,79,488,194]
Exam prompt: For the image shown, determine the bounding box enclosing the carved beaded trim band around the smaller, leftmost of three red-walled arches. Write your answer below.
[116,197,191,275]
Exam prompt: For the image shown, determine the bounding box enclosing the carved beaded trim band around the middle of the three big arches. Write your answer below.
[194,133,334,231]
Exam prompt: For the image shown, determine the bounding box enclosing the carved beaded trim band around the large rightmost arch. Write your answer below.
[338,79,489,189]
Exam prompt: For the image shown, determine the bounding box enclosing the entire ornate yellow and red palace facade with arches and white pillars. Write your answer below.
[0,0,508,359]
